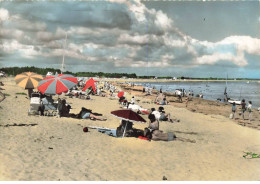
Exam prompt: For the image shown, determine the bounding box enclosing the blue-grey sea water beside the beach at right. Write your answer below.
[132,81,260,108]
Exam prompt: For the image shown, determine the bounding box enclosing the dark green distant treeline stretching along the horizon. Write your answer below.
[0,66,259,80]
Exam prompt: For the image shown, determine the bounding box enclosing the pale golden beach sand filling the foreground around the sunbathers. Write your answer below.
[0,78,260,181]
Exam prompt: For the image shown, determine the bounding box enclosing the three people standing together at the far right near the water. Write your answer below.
[231,99,252,121]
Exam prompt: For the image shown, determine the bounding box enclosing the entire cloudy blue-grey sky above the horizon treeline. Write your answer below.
[0,0,260,78]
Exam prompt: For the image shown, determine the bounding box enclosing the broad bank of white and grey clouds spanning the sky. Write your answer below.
[0,0,260,74]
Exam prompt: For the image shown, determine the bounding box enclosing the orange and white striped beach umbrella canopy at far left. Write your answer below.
[15,72,43,89]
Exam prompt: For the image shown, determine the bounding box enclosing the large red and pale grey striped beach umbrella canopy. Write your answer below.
[38,74,77,95]
